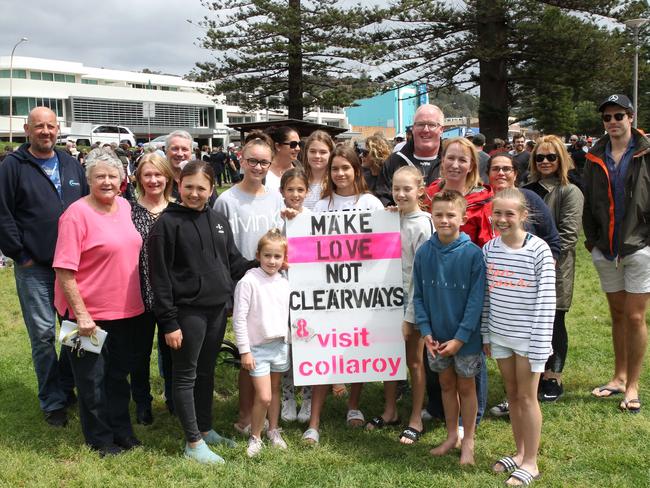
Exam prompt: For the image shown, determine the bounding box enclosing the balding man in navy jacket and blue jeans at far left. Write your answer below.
[0,107,88,427]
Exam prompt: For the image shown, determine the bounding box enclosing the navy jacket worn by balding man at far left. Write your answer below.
[0,143,88,266]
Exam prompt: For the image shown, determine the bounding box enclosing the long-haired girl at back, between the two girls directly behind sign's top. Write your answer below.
[302,130,334,210]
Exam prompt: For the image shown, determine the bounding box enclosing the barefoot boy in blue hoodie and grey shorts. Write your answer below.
[413,190,485,464]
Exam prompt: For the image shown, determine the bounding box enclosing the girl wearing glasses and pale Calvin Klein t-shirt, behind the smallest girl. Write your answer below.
[214,132,284,435]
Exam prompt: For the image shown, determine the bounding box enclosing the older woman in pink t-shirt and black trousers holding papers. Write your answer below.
[52,149,144,456]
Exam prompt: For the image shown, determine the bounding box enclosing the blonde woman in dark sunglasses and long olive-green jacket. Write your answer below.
[526,136,584,402]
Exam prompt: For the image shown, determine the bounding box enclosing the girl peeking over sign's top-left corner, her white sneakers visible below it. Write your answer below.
[280,168,311,423]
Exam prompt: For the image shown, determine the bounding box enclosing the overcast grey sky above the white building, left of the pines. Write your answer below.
[0,0,210,75]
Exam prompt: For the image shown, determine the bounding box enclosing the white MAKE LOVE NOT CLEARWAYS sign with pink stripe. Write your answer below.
[287,210,406,386]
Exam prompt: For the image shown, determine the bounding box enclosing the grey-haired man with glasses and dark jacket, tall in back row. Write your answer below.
[375,104,445,205]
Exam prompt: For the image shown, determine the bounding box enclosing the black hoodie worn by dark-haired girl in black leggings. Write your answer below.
[146,203,255,333]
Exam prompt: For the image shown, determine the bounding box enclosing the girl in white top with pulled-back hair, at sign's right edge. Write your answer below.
[366,166,434,444]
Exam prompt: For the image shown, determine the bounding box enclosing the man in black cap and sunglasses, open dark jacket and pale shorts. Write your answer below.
[583,94,650,413]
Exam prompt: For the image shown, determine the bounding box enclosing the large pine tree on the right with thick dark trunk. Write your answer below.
[375,0,641,139]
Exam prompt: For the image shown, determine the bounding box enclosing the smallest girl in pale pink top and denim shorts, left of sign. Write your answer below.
[233,229,289,457]
